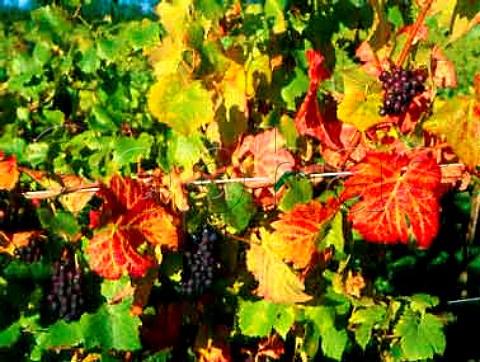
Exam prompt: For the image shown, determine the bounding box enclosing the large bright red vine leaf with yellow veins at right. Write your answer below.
[342,153,441,248]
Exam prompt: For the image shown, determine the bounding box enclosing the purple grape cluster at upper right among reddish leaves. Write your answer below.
[379,67,427,117]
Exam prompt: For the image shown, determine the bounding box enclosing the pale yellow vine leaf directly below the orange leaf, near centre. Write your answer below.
[247,229,312,303]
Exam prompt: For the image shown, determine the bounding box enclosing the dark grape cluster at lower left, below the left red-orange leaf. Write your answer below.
[47,250,84,322]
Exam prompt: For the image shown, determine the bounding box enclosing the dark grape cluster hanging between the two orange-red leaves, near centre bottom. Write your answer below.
[182,228,218,295]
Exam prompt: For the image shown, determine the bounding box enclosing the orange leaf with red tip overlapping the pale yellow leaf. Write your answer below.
[270,199,340,269]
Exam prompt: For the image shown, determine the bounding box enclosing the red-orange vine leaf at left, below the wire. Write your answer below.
[86,176,178,279]
